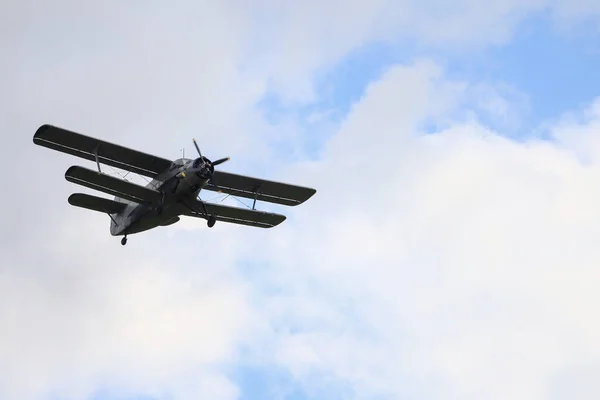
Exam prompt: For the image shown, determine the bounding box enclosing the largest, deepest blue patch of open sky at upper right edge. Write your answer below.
[448,15,600,123]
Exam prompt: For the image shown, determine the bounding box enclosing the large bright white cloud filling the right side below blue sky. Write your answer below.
[221,62,600,399]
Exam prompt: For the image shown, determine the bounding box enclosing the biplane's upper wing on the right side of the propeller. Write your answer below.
[204,171,317,206]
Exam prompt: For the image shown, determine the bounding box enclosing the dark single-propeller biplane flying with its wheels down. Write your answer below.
[33,124,316,245]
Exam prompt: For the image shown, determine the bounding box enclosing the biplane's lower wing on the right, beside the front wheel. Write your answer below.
[181,200,285,228]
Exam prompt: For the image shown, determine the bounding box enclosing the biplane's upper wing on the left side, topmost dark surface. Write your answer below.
[33,125,171,178]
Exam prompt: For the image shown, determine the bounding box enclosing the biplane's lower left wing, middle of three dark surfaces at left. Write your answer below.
[65,166,161,204]
